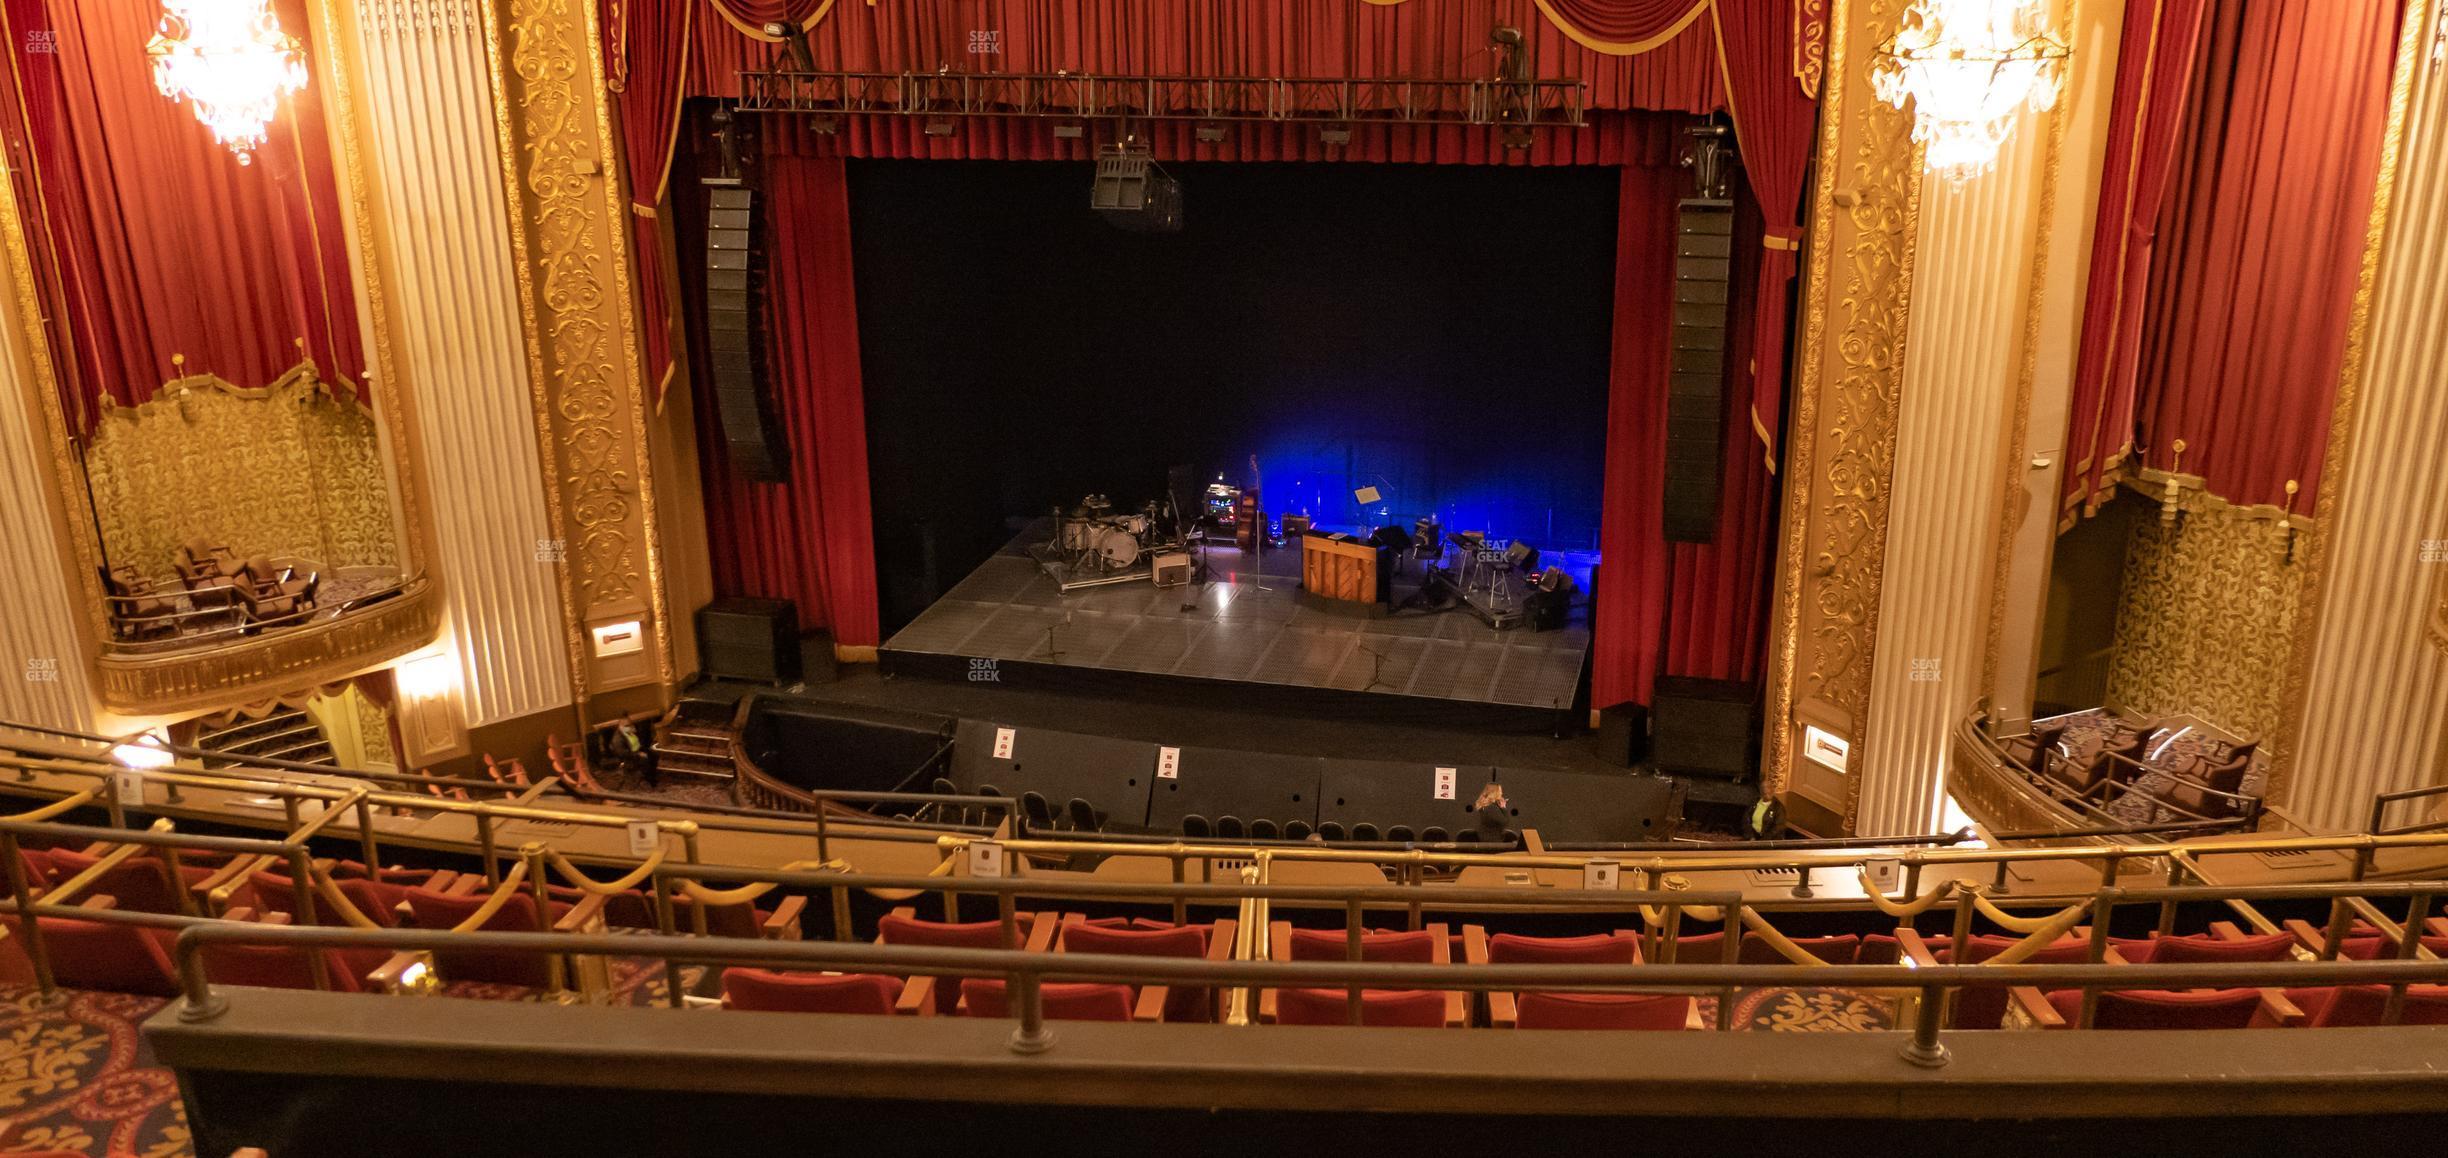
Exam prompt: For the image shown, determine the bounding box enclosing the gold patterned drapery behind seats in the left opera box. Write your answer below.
[86,365,399,578]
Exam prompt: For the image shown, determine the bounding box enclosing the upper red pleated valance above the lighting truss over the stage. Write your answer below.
[688,0,1723,113]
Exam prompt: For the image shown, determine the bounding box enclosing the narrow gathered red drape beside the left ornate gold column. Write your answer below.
[597,0,698,406]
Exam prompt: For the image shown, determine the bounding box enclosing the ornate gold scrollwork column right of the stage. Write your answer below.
[1765,0,1922,832]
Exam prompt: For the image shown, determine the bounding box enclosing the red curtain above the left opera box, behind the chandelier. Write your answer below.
[5,0,365,431]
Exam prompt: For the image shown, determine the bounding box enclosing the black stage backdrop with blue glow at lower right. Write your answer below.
[849,162,1616,632]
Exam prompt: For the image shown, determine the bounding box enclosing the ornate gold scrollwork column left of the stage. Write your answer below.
[485,0,676,710]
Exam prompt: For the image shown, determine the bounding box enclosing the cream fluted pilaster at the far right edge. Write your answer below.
[2272,0,2448,830]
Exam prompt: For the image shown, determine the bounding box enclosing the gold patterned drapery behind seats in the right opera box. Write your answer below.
[2108,490,2311,742]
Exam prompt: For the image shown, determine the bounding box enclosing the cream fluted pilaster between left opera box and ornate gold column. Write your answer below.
[353,0,573,727]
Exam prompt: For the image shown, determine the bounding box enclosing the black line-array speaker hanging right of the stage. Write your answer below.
[1665,201,1733,544]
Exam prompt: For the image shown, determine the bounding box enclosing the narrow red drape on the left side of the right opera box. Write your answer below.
[2061,0,2208,519]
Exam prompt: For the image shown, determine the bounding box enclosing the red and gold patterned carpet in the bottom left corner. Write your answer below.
[0,989,193,1158]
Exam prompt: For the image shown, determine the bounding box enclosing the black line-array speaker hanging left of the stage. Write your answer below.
[705,176,791,482]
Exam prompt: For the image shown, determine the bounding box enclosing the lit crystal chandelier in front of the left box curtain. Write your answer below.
[144,0,306,164]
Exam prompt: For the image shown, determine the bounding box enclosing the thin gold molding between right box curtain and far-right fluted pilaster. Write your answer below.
[2264,0,2448,805]
